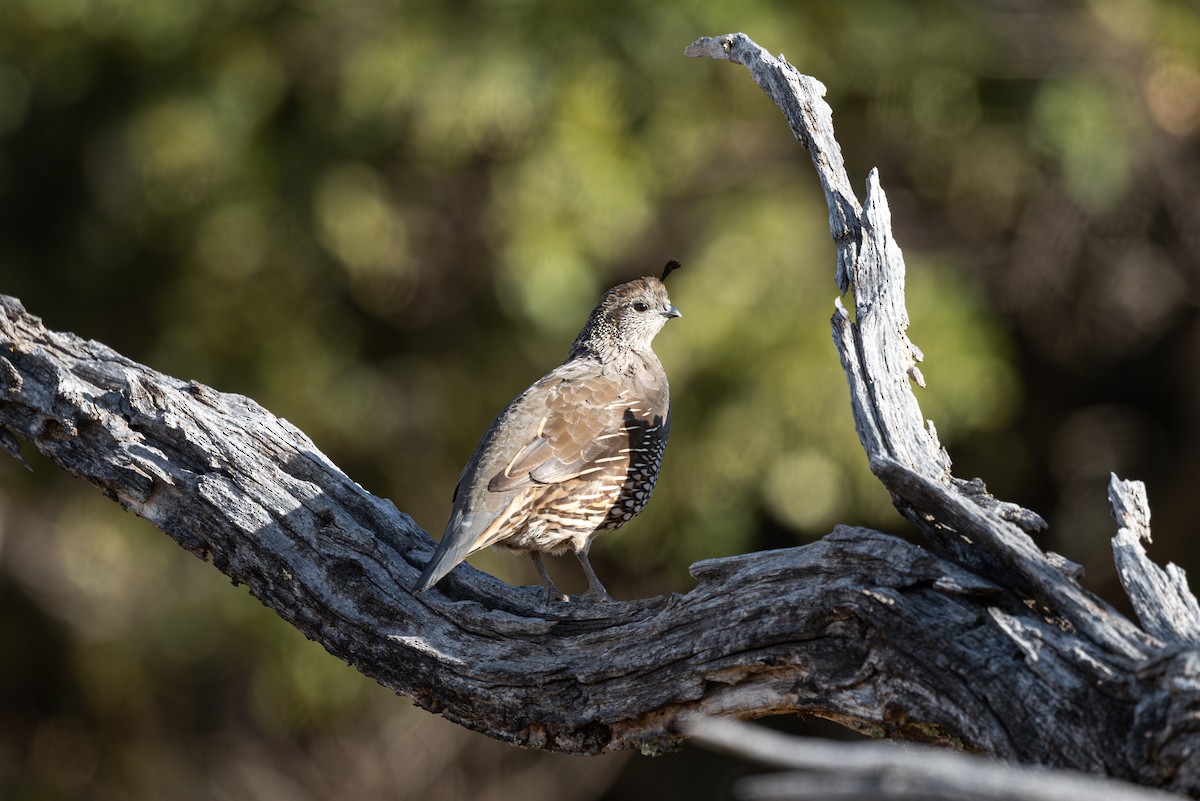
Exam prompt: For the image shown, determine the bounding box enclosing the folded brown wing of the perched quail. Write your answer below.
[487,377,649,492]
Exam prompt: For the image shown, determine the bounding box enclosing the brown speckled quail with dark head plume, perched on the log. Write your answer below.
[414,259,682,603]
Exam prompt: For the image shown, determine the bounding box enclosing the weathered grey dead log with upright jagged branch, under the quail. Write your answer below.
[0,34,1200,795]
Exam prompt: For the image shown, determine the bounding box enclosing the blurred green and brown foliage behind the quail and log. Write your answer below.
[0,0,1200,801]
